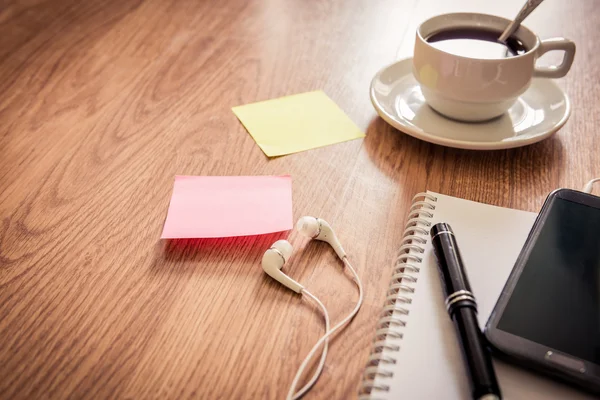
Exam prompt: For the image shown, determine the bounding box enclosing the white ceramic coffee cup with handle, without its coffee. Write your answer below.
[413,13,575,121]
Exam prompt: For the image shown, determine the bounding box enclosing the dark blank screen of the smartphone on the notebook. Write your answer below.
[497,198,600,364]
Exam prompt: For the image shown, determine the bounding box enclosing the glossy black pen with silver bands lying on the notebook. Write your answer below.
[431,222,502,400]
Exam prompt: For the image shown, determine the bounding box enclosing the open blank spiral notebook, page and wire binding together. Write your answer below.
[359,192,593,400]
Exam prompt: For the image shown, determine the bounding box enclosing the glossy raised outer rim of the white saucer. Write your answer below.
[369,57,571,150]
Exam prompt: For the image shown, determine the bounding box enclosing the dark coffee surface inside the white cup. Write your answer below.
[425,28,527,59]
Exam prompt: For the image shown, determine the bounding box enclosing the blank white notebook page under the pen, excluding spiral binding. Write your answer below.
[380,192,593,400]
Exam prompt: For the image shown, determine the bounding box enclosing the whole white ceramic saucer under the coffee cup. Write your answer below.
[371,58,571,150]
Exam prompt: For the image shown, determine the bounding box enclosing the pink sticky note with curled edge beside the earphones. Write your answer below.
[161,175,292,239]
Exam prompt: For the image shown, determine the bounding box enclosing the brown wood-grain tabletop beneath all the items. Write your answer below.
[0,0,600,399]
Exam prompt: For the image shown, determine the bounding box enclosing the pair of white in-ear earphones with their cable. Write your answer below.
[262,217,363,400]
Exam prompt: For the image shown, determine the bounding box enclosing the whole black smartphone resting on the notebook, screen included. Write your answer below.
[485,189,600,394]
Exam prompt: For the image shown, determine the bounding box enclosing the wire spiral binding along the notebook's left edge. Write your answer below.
[358,193,437,400]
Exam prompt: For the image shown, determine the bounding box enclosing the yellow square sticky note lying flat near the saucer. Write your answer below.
[232,90,365,157]
